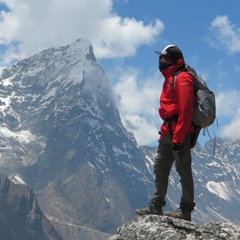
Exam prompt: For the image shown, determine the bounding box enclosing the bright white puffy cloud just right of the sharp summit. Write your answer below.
[93,16,163,58]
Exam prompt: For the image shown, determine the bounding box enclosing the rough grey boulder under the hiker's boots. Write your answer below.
[108,215,240,240]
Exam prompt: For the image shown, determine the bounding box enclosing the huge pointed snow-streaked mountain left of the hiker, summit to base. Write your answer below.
[0,39,153,239]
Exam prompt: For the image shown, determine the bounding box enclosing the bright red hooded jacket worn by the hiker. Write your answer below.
[159,59,195,144]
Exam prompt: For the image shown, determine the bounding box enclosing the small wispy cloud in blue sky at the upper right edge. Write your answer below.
[207,16,240,54]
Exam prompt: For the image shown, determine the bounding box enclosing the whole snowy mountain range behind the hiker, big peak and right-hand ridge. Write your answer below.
[0,39,240,240]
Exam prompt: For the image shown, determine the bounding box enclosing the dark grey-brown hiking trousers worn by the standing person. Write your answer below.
[152,134,195,211]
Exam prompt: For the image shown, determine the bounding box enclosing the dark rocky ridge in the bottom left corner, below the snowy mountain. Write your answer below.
[0,174,62,240]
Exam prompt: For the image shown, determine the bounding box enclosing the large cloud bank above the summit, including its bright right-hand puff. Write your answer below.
[0,0,164,64]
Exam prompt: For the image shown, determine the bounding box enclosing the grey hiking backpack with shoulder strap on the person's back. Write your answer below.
[174,64,216,128]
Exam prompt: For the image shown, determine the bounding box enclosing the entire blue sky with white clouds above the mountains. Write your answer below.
[0,0,240,146]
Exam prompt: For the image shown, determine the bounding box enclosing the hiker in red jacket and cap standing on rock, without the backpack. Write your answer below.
[136,45,199,221]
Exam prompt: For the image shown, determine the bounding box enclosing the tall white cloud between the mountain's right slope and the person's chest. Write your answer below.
[114,68,163,145]
